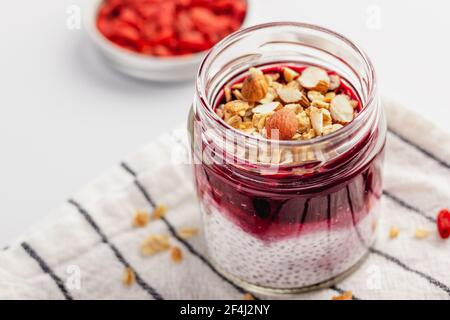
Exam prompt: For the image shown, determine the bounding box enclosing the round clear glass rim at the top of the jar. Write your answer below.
[195,21,377,147]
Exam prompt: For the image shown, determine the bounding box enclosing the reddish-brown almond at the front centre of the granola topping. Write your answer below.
[266,108,298,140]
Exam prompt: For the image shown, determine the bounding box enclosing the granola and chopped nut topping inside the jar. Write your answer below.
[215,67,361,140]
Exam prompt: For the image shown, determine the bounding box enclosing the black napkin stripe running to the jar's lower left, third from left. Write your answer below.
[120,162,253,299]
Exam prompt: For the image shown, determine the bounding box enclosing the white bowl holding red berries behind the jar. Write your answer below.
[85,0,248,82]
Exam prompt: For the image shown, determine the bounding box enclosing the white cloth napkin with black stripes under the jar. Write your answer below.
[0,101,450,299]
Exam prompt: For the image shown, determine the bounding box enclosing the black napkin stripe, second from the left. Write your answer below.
[68,199,164,300]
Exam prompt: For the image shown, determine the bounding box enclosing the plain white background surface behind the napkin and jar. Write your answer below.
[0,0,450,245]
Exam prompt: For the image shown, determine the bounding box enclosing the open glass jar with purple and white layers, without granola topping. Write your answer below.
[189,22,386,293]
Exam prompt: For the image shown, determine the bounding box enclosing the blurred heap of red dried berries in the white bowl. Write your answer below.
[97,0,247,57]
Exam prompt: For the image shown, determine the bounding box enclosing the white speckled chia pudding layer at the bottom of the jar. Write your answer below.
[201,199,379,289]
